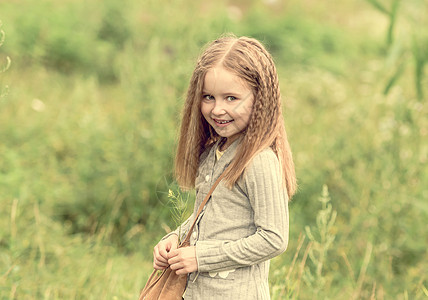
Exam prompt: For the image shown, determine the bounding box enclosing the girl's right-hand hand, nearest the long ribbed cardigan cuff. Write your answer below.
[168,246,198,275]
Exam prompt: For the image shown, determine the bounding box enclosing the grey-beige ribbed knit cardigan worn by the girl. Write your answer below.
[164,139,288,300]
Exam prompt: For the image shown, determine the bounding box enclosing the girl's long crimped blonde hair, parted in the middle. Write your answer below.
[175,36,297,199]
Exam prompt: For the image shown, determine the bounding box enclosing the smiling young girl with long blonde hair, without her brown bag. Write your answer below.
[153,36,296,300]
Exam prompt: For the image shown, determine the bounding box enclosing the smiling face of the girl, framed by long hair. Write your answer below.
[201,66,254,149]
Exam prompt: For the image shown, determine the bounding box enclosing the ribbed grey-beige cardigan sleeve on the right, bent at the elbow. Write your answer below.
[196,149,288,272]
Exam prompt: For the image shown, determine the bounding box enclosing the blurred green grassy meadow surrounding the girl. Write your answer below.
[0,0,428,299]
